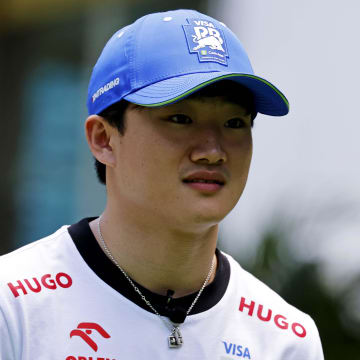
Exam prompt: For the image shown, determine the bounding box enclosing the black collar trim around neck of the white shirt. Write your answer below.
[68,218,230,322]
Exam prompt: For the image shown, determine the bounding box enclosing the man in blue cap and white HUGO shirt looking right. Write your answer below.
[0,10,323,360]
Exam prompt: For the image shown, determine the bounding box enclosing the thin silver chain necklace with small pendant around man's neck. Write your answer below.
[97,216,215,348]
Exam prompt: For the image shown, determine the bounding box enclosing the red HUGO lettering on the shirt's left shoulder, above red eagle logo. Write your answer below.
[8,272,72,297]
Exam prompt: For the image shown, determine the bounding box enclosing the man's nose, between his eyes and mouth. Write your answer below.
[190,129,227,165]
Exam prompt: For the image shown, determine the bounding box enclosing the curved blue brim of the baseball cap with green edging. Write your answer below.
[124,72,289,116]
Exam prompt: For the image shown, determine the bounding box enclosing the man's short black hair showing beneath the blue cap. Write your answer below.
[95,80,257,185]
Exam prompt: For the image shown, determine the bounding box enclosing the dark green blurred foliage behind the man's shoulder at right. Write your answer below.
[226,226,360,360]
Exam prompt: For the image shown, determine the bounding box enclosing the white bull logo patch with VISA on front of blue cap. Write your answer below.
[183,19,229,66]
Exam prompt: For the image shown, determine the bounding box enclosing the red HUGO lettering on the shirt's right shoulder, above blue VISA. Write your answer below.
[239,297,306,338]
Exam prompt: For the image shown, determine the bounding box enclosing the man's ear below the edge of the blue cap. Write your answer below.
[85,115,115,167]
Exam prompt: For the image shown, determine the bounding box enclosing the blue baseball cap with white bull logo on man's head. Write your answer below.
[87,10,289,116]
